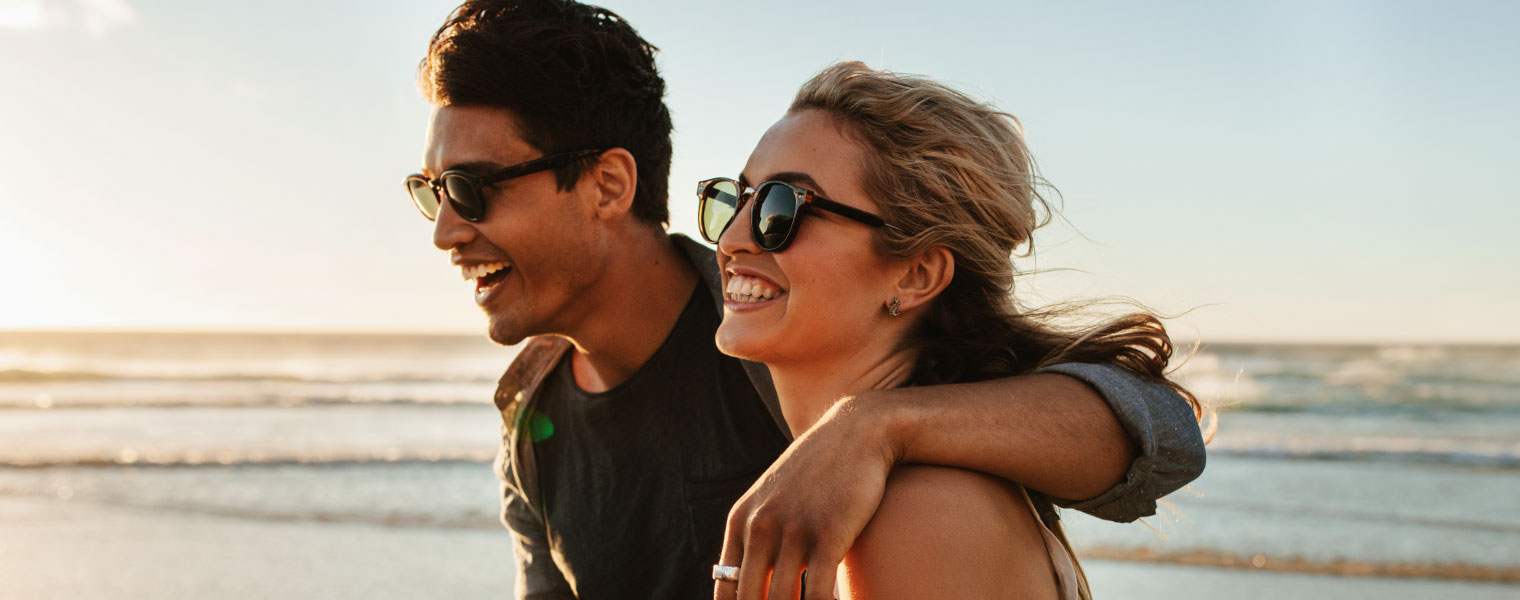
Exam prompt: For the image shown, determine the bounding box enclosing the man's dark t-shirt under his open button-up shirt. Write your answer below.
[534,284,787,600]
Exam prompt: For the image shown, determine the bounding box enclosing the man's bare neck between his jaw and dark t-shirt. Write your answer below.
[567,230,701,393]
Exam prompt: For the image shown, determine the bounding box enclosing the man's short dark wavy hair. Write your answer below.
[416,0,670,225]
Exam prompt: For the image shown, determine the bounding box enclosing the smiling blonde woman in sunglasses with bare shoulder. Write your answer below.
[699,62,1196,598]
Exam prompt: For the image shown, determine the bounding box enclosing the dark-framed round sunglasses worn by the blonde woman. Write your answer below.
[696,178,897,252]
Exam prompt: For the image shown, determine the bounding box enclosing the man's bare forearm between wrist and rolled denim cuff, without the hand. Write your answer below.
[847,374,1138,500]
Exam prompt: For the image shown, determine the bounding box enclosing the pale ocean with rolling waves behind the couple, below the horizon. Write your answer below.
[0,333,1520,598]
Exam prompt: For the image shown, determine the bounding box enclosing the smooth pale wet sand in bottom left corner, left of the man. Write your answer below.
[0,497,512,600]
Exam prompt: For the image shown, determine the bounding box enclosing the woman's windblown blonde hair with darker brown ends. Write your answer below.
[790,62,1202,416]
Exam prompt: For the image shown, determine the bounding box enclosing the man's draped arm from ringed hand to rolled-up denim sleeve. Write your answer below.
[714,370,1204,600]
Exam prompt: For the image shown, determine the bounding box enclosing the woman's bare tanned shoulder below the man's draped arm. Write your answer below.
[841,465,1056,598]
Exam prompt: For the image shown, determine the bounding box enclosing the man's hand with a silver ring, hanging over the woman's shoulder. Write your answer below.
[713,396,900,600]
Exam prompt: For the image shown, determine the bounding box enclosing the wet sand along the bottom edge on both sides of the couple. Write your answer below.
[0,495,1520,600]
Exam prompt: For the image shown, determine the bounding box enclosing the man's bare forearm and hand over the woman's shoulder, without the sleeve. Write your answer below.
[714,375,1135,600]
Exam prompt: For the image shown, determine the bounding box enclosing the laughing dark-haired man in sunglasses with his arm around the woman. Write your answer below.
[407,0,1204,598]
